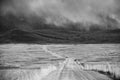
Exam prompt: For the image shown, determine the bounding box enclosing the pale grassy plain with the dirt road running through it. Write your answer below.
[0,44,120,80]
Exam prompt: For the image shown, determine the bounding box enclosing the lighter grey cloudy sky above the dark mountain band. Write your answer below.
[1,0,120,23]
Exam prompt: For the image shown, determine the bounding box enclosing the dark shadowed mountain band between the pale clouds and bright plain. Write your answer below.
[0,15,120,44]
